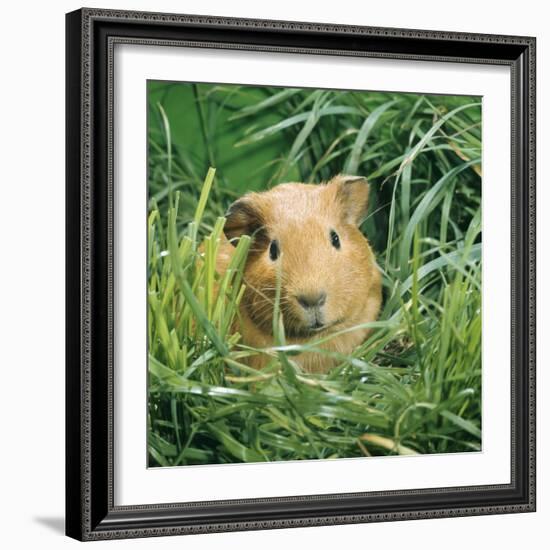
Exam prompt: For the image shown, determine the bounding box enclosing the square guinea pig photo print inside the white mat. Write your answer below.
[144,80,482,467]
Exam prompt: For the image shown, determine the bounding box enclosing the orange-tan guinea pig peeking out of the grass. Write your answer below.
[217,175,382,372]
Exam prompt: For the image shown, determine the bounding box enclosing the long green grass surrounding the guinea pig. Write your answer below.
[148,82,481,466]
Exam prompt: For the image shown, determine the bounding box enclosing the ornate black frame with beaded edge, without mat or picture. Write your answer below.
[66,9,535,540]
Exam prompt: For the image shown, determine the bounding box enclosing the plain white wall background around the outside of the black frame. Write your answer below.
[0,0,550,550]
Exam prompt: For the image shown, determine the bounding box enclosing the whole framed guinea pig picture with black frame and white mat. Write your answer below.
[66,9,535,540]
